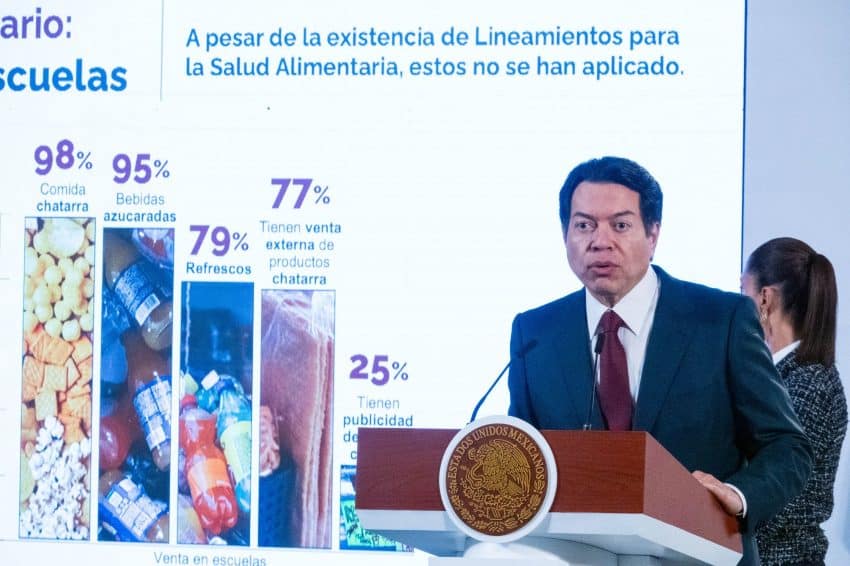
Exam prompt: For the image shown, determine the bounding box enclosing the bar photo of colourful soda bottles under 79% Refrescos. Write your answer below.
[176,282,254,546]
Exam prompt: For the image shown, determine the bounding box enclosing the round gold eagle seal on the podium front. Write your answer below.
[445,424,549,536]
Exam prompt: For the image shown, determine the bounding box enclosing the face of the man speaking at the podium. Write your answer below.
[564,181,659,307]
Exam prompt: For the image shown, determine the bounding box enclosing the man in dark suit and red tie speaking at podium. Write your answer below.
[508,157,812,564]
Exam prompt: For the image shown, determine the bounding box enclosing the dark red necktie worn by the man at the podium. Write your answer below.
[597,310,632,430]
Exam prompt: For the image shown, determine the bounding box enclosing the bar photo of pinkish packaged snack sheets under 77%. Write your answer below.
[258,290,335,548]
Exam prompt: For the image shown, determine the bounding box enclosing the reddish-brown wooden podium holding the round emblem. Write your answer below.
[355,428,742,565]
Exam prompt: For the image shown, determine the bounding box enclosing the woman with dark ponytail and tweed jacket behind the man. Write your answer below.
[741,238,847,564]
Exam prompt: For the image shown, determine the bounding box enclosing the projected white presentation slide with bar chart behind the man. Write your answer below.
[0,0,745,566]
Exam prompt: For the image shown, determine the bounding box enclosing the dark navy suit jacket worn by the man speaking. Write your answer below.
[508,266,812,564]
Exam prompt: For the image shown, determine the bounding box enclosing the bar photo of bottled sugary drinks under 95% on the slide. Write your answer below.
[97,228,174,542]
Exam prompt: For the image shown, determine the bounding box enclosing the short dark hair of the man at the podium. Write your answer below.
[559,156,663,233]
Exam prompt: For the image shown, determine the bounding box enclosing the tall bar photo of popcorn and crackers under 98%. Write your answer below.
[19,218,95,540]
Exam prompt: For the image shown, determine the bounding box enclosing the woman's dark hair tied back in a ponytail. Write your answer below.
[744,238,838,367]
